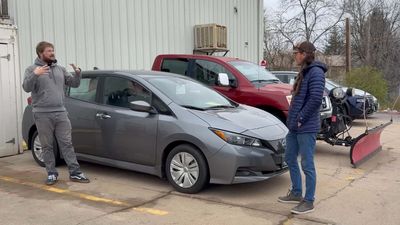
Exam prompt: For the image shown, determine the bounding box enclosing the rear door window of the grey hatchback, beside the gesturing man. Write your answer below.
[69,77,98,102]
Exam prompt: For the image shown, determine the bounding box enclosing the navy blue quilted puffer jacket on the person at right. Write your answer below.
[286,61,327,133]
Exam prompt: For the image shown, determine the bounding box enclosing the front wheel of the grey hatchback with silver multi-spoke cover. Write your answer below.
[165,144,209,194]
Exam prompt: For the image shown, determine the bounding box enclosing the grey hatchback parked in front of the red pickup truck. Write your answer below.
[22,70,288,193]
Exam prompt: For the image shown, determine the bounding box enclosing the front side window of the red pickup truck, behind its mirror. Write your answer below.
[193,59,235,86]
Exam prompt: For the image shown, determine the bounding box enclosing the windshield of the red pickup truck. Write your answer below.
[229,61,280,83]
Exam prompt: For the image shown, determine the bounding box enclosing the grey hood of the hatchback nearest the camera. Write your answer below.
[190,105,287,140]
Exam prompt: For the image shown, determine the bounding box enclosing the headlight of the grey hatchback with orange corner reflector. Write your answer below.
[210,128,262,147]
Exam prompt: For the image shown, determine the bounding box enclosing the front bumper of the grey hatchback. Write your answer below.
[208,144,288,184]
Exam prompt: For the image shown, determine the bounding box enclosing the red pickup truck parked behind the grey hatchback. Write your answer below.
[152,54,332,123]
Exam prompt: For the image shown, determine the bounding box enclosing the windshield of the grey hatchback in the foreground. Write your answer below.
[147,77,236,110]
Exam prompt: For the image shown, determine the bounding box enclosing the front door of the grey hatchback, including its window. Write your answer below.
[96,76,158,165]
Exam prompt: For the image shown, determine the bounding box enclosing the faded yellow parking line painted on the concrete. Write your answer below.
[0,176,168,216]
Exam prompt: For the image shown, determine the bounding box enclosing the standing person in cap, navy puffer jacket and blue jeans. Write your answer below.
[278,41,327,214]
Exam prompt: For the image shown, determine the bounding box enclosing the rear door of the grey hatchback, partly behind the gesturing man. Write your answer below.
[65,75,103,156]
